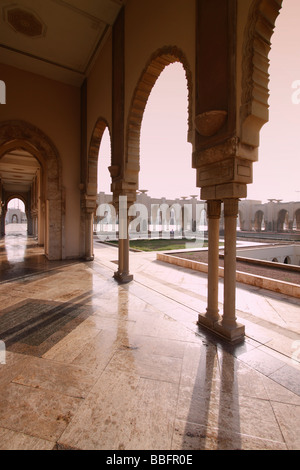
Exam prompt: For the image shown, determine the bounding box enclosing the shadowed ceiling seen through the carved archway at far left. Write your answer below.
[0,149,40,193]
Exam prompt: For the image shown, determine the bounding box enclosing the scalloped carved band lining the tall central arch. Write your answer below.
[125,46,193,192]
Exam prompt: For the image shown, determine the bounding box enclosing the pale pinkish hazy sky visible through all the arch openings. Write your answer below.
[98,0,300,201]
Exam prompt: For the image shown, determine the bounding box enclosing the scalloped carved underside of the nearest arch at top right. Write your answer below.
[240,0,282,147]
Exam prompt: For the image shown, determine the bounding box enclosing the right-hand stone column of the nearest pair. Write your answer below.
[216,198,245,341]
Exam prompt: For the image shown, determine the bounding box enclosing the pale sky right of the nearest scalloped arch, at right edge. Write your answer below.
[248,0,300,201]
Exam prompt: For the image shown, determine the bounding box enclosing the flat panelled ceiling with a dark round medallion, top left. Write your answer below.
[0,0,125,86]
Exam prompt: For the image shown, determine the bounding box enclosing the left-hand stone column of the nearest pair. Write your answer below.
[198,200,221,327]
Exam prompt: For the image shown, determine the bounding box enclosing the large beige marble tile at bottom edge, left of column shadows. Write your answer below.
[58,372,177,450]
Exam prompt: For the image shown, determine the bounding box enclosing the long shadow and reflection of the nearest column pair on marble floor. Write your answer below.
[182,336,242,450]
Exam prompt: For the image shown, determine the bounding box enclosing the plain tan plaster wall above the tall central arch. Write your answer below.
[125,0,196,134]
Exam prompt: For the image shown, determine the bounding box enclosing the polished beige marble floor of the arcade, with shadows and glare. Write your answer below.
[0,234,300,450]
